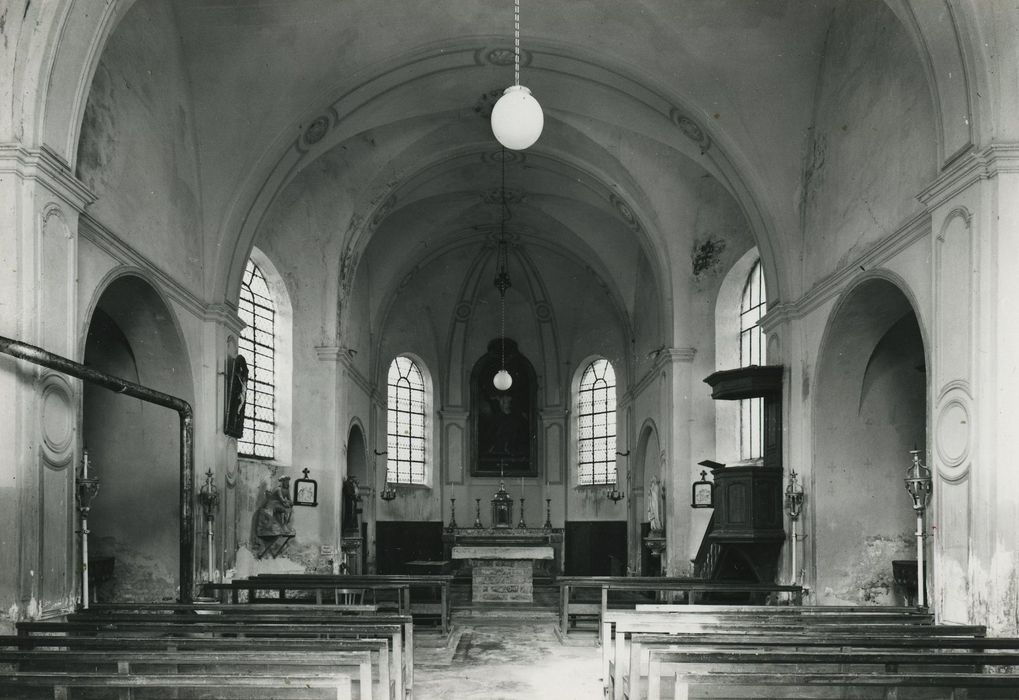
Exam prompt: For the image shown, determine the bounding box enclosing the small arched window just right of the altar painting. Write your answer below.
[577,359,615,486]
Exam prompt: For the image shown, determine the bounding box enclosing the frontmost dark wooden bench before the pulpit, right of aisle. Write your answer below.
[555,576,803,642]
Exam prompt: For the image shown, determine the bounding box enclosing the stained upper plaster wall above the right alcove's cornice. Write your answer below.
[800,0,936,288]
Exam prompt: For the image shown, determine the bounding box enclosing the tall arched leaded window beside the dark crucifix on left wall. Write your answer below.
[237,259,276,460]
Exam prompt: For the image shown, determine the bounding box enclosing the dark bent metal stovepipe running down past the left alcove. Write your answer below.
[0,335,195,603]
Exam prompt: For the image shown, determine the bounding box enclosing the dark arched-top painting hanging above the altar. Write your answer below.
[471,338,538,477]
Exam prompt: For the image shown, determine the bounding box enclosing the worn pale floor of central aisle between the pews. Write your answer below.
[414,620,602,700]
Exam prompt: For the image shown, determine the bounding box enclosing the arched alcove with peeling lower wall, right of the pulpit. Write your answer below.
[808,279,926,604]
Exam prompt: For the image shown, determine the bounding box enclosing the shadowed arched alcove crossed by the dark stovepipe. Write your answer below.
[83,275,194,600]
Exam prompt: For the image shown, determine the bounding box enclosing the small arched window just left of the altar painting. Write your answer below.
[386,356,427,484]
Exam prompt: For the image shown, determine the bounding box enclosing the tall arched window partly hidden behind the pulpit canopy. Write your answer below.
[740,258,767,460]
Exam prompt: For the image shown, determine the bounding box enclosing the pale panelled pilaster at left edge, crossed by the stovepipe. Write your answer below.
[0,144,94,617]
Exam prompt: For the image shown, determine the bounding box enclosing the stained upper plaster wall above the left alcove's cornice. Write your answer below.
[77,2,204,291]
